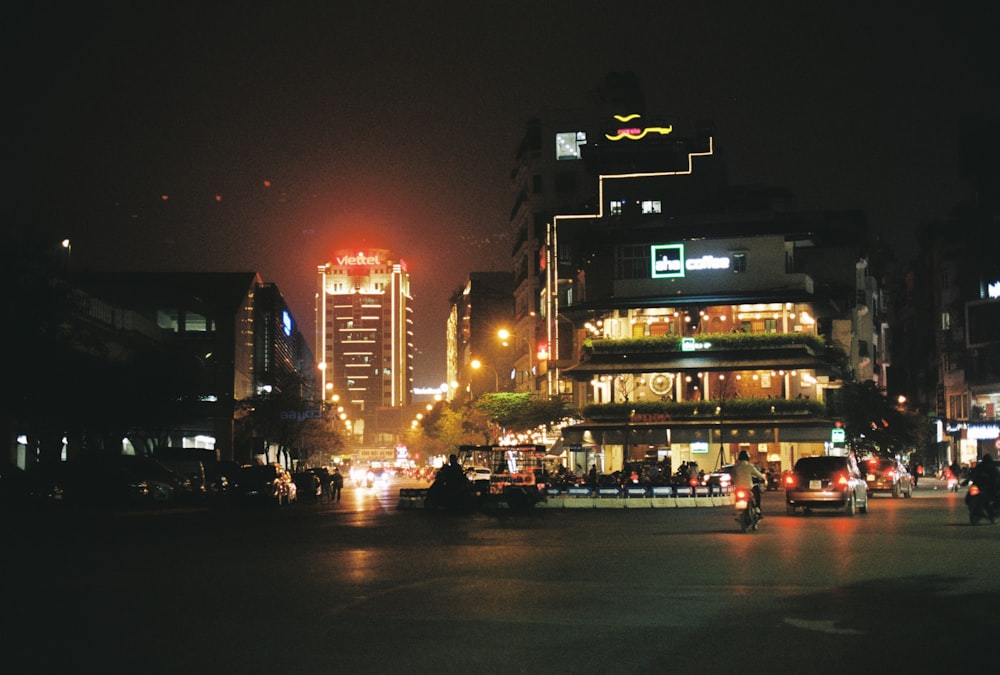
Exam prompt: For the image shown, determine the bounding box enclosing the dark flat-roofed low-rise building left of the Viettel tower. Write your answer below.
[74,272,312,462]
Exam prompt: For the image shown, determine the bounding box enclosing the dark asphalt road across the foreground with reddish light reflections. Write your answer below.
[2,480,1000,673]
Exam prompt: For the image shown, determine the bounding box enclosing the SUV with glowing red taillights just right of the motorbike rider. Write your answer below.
[785,455,868,516]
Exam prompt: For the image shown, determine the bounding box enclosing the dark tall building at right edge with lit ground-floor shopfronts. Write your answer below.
[909,117,1000,464]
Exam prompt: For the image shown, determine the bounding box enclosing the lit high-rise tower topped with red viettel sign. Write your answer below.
[316,249,413,445]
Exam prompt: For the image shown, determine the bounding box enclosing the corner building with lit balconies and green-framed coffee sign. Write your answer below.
[542,109,885,478]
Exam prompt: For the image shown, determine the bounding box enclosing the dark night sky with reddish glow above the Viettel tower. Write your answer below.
[11,0,1000,386]
